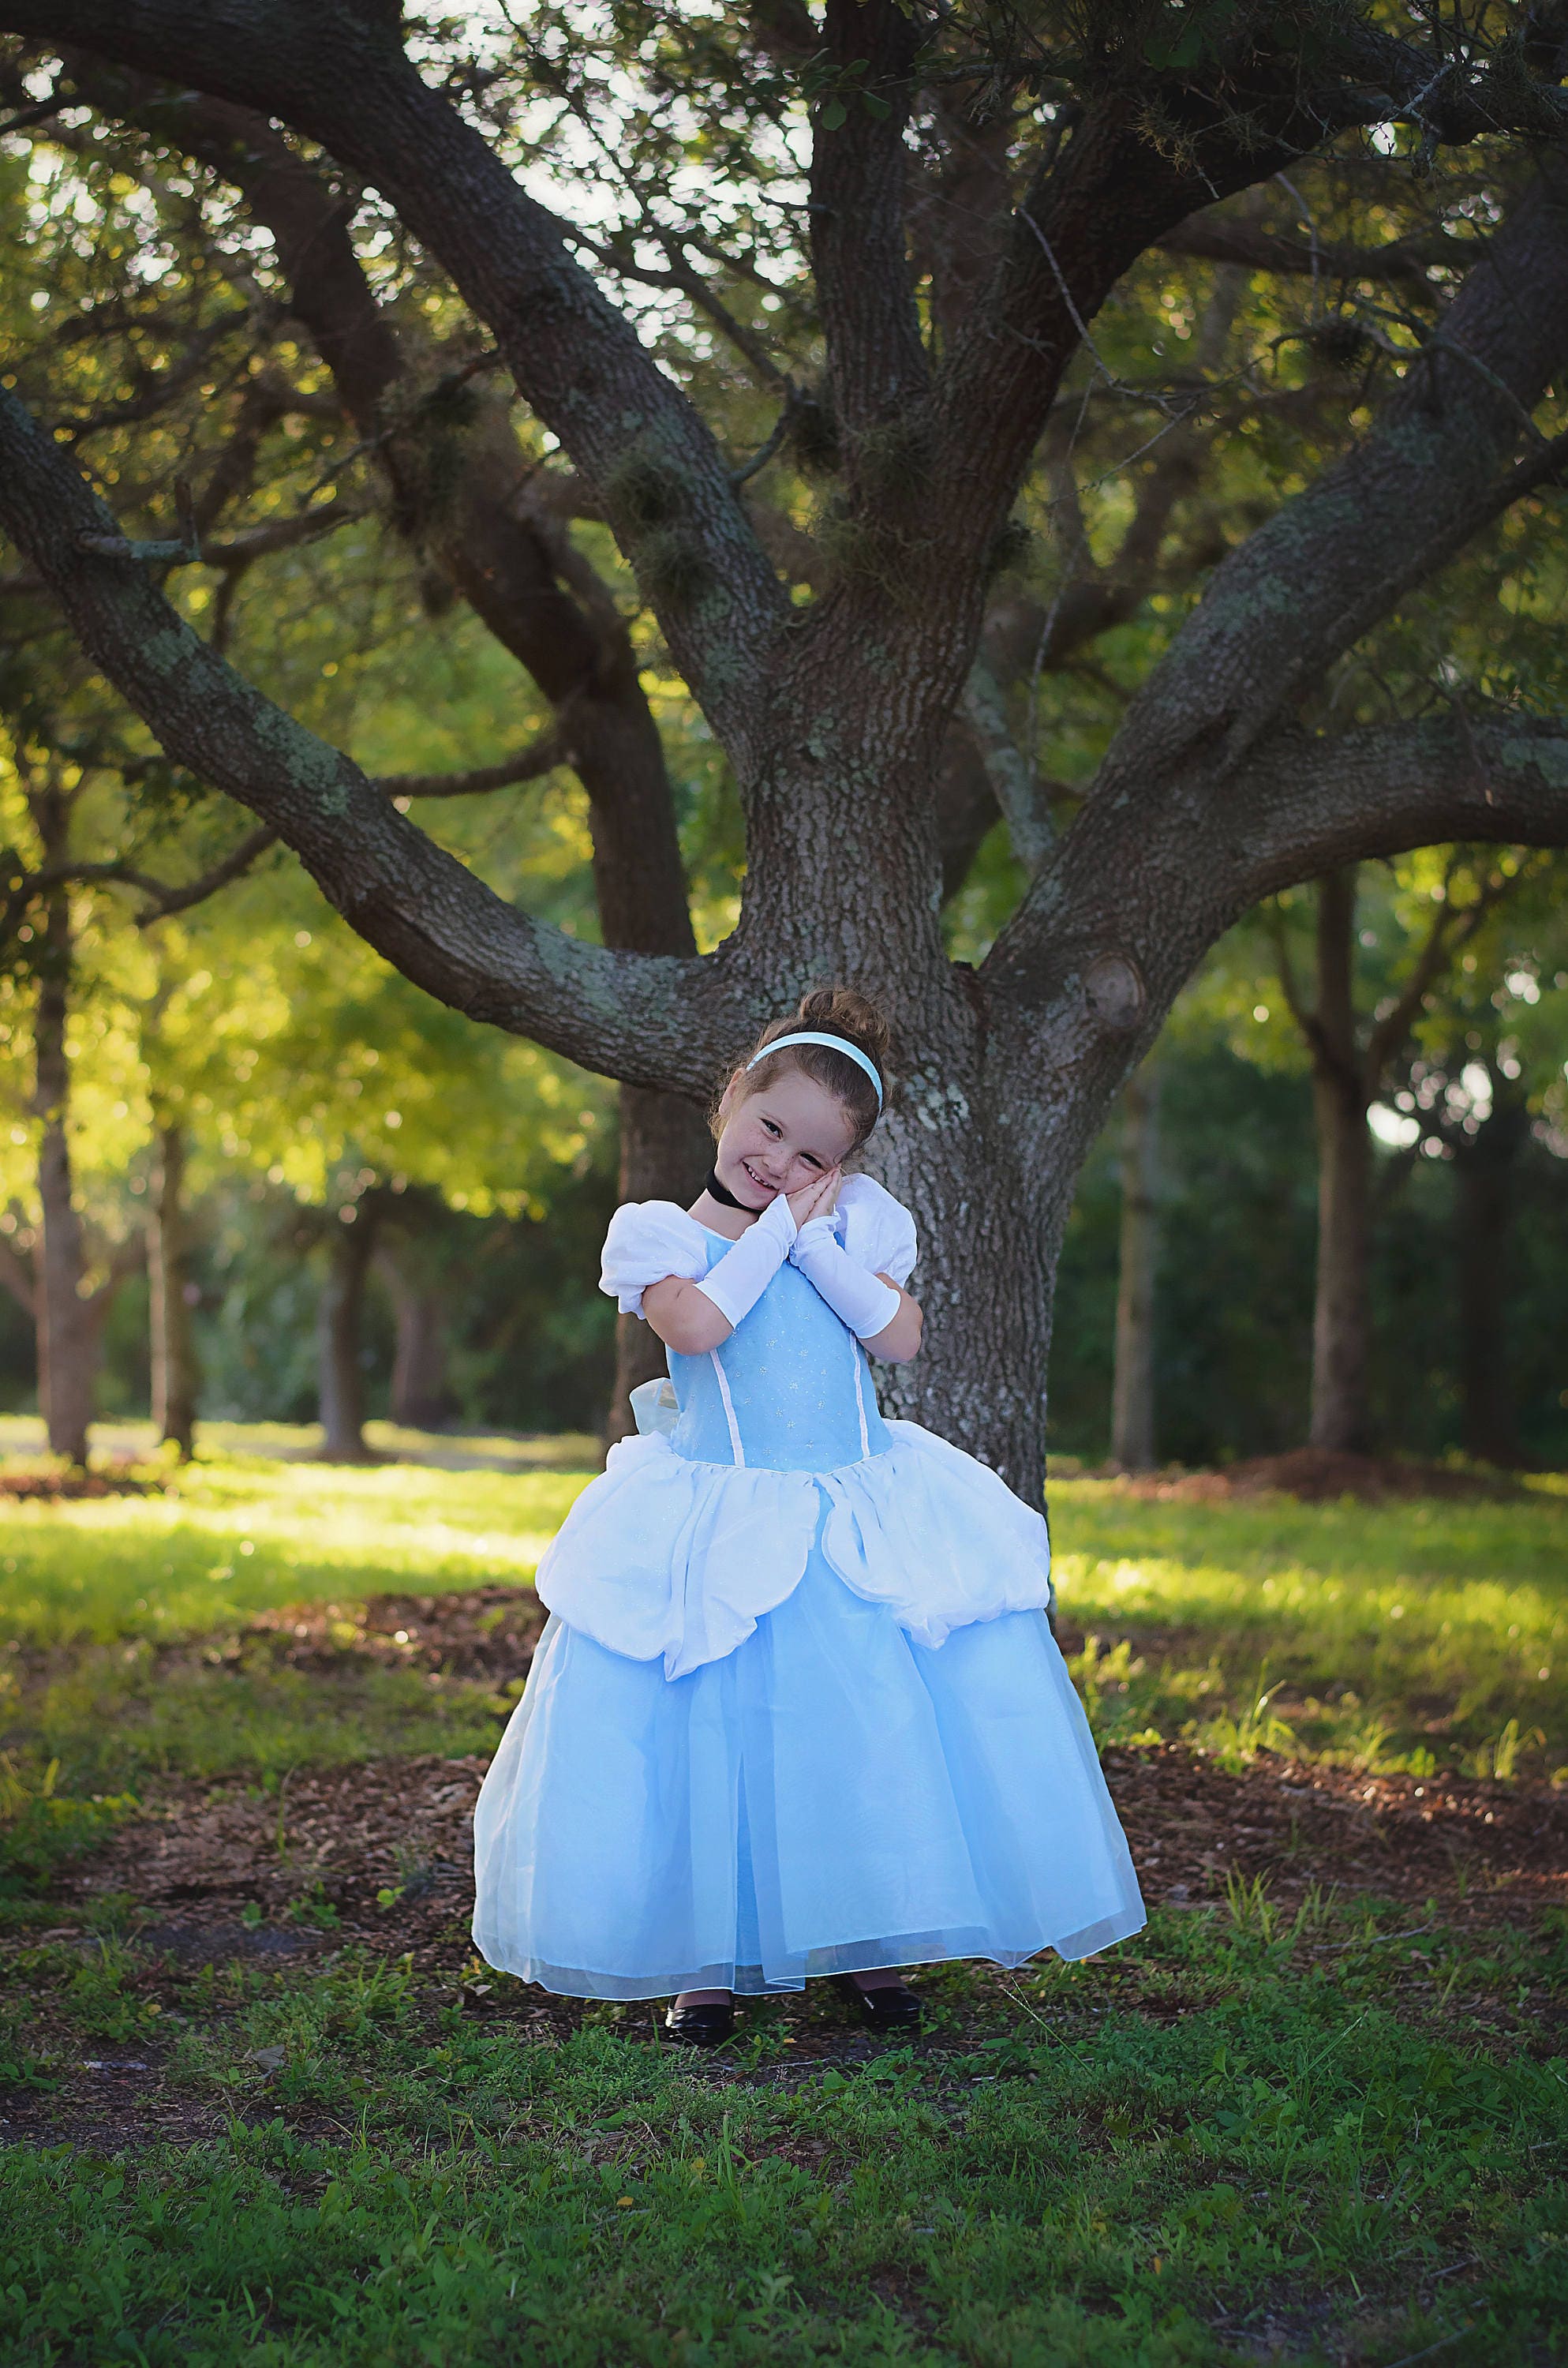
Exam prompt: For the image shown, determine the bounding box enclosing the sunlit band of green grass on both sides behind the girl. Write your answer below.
[0,1426,1568,1790]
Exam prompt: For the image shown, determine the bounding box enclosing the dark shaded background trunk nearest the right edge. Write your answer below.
[1454,1099,1530,1463]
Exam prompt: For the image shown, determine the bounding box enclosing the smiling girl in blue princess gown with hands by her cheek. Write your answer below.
[473,987,1144,2044]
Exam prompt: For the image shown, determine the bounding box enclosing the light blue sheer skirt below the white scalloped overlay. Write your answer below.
[473,1546,1144,1999]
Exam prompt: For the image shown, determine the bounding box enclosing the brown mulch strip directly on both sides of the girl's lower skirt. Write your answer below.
[59,1745,1568,1963]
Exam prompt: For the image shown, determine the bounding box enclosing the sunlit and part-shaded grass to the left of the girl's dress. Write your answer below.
[0,1442,587,1793]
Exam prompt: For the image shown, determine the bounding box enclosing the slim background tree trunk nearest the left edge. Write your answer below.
[33,876,104,1463]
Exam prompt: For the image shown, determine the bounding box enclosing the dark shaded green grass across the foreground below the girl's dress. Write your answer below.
[0,1892,1568,2368]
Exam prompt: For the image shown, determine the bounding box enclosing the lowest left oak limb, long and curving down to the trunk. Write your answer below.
[0,388,748,1099]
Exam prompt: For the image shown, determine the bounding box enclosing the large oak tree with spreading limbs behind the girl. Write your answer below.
[0,0,1568,1492]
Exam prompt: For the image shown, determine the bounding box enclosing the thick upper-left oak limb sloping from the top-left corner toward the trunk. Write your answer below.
[15,0,791,739]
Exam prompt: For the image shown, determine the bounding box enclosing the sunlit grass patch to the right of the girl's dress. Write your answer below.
[1052,1480,1568,1776]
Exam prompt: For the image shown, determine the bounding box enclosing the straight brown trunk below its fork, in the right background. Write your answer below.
[1310,867,1372,1454]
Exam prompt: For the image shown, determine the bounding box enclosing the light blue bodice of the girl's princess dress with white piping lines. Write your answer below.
[670,1227,891,1473]
